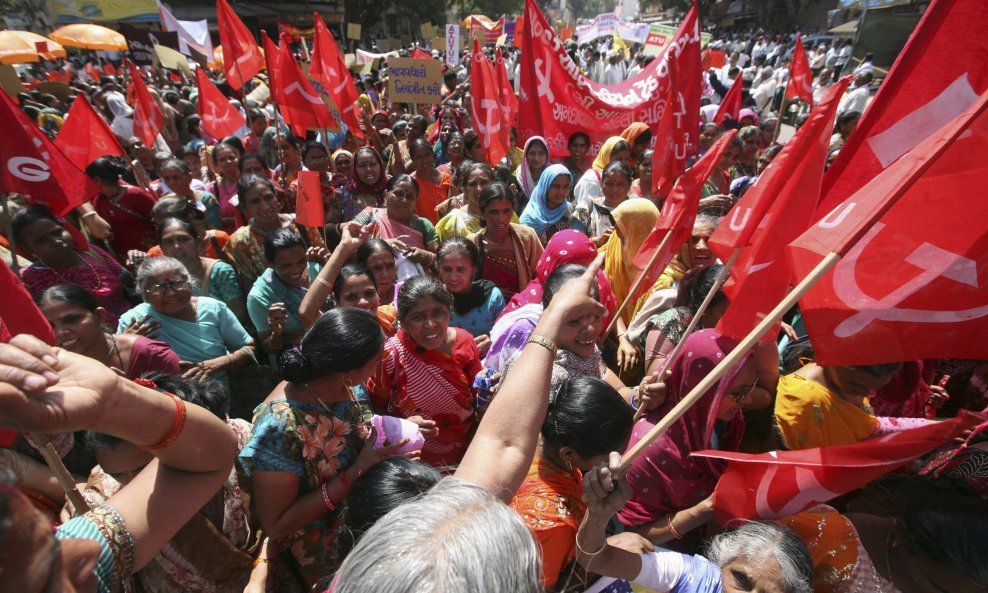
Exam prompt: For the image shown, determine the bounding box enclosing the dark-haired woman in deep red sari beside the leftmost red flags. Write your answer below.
[86,157,155,261]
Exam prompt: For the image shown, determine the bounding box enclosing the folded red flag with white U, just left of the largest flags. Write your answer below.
[709,76,851,340]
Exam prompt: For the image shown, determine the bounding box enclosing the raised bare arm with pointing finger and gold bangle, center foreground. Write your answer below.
[455,256,606,502]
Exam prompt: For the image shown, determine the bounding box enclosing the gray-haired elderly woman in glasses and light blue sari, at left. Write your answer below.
[118,257,254,391]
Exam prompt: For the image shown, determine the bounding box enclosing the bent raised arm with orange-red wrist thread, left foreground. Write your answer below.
[0,335,237,570]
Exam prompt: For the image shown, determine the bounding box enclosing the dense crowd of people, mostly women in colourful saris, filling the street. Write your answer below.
[0,16,988,593]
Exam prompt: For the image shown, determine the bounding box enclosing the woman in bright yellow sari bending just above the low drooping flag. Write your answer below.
[775,362,929,449]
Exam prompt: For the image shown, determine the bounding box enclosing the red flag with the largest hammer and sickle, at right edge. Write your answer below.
[789,92,988,365]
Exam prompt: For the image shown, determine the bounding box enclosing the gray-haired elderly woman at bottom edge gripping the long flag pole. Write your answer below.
[576,453,813,593]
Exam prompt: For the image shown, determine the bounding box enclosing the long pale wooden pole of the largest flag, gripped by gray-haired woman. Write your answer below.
[621,252,841,474]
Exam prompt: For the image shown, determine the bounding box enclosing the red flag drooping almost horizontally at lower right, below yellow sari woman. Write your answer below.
[693,410,986,525]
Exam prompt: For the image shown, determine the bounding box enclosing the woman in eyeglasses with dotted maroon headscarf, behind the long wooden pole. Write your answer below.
[618,329,756,552]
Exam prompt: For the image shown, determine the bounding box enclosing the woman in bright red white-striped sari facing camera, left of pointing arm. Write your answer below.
[368,276,480,467]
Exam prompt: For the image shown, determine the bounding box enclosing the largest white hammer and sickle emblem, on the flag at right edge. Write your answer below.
[834,223,988,338]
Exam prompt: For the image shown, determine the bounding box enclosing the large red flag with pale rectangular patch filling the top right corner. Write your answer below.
[814,0,988,219]
